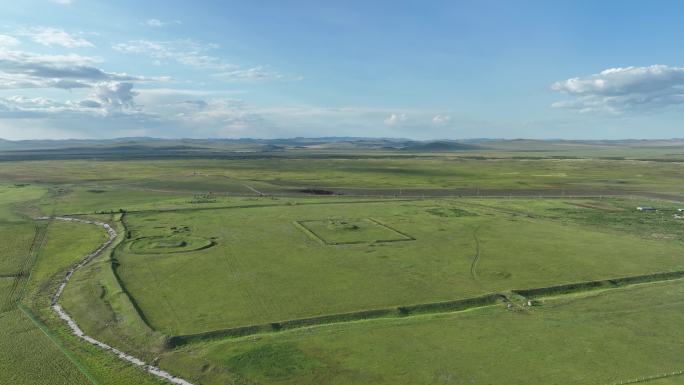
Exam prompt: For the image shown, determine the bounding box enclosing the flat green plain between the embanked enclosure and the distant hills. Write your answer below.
[0,154,684,200]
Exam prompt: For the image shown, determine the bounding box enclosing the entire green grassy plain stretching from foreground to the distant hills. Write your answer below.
[0,143,684,385]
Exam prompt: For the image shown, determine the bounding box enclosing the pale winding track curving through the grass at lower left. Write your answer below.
[37,217,194,385]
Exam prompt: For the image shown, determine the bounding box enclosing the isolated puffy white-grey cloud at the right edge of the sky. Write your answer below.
[551,65,684,114]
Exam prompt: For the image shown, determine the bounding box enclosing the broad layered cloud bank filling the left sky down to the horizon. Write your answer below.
[0,19,451,139]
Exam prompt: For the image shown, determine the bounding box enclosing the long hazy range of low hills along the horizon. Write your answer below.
[0,137,684,160]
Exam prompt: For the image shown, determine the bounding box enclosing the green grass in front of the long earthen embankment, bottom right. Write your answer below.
[161,281,684,385]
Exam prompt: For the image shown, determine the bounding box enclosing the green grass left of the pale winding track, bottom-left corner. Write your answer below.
[0,216,166,385]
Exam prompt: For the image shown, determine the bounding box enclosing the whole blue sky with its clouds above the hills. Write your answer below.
[0,0,684,139]
